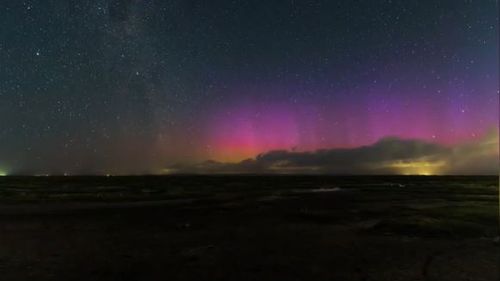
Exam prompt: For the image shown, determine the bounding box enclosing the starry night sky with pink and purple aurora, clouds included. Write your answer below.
[0,0,499,174]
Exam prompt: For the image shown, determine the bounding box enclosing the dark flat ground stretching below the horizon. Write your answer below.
[0,176,500,281]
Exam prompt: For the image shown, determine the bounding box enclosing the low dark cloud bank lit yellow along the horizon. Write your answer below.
[165,130,499,175]
